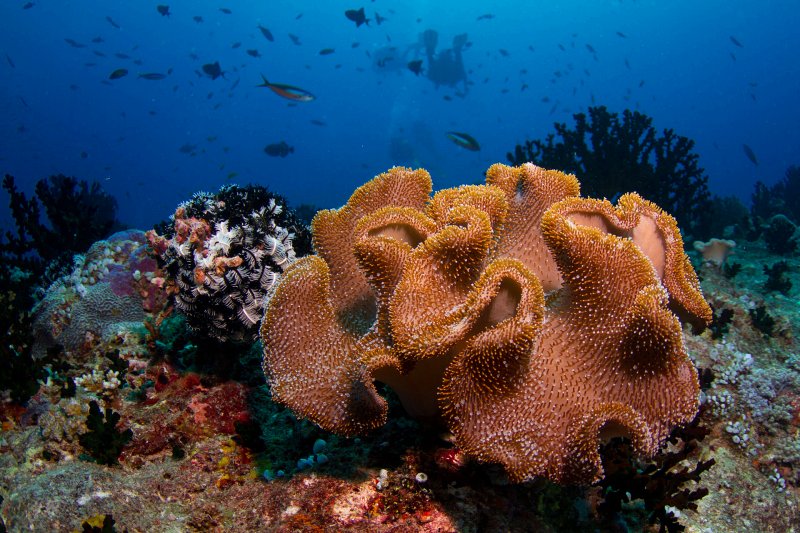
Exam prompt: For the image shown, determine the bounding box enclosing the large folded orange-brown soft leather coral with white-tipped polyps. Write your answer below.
[261,163,711,483]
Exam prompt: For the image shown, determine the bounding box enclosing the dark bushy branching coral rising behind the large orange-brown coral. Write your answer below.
[507,106,712,239]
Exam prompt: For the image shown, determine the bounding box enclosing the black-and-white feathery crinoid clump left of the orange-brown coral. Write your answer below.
[148,185,311,342]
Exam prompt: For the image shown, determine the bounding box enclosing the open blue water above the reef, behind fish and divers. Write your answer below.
[0,0,800,228]
